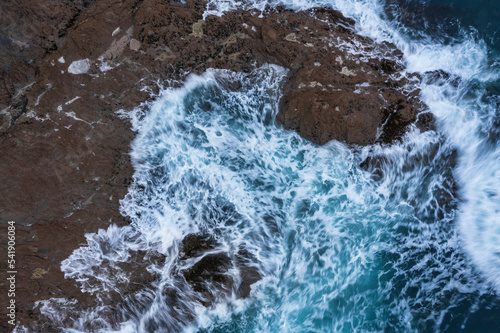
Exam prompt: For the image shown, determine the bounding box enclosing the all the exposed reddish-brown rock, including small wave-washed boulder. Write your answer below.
[0,0,430,329]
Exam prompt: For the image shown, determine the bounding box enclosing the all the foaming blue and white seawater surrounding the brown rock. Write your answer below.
[35,0,500,332]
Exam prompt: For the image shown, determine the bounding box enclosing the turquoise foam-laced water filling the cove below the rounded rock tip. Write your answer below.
[126,67,464,332]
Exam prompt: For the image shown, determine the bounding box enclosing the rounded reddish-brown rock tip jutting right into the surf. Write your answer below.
[277,9,422,145]
